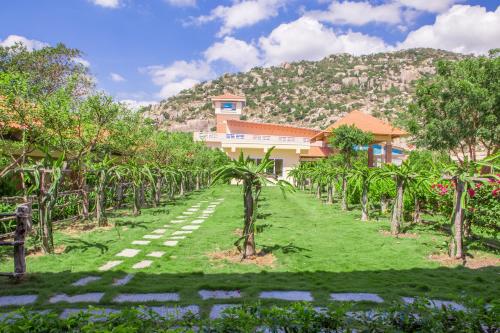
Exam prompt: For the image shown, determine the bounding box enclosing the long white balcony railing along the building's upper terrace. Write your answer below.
[194,132,310,147]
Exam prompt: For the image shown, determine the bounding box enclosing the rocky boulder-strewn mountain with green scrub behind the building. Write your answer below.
[144,49,465,131]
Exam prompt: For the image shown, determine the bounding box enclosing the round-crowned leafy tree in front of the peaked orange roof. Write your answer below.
[330,125,373,210]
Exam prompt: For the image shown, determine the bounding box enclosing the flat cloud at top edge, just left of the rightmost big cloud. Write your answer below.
[306,1,401,25]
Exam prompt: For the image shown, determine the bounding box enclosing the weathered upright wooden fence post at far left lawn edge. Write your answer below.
[14,205,31,280]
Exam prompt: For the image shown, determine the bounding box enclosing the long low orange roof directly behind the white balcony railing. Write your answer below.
[227,119,320,138]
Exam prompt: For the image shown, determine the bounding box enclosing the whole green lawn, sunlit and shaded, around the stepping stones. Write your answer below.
[0,186,500,310]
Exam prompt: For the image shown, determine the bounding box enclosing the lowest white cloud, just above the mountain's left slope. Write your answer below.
[145,61,215,98]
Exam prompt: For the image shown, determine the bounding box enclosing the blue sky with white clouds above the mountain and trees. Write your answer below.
[0,0,500,106]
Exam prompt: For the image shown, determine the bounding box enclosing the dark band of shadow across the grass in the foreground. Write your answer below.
[0,264,500,312]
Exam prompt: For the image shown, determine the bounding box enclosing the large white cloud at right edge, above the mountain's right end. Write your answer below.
[398,5,500,54]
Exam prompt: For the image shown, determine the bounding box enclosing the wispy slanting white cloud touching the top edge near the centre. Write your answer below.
[194,0,286,37]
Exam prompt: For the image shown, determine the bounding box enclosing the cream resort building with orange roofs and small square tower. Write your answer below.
[194,94,405,179]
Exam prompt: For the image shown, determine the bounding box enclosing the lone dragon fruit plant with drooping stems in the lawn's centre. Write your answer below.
[212,147,293,258]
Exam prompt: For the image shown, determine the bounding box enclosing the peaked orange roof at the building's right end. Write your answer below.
[313,110,407,140]
